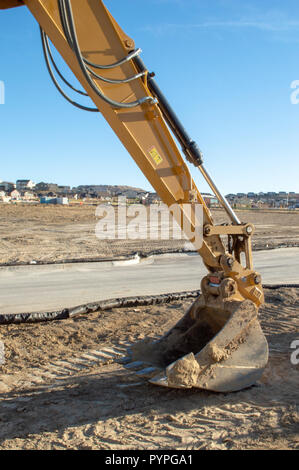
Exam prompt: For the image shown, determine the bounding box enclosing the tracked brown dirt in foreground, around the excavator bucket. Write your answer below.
[0,288,299,450]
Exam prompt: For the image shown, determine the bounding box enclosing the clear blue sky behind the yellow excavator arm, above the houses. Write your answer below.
[0,0,299,194]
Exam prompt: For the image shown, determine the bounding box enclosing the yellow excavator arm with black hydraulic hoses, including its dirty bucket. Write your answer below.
[0,0,268,391]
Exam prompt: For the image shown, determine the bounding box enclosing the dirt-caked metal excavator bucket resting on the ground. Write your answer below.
[126,278,268,392]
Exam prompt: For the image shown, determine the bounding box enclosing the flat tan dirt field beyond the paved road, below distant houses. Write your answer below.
[0,204,299,264]
